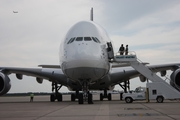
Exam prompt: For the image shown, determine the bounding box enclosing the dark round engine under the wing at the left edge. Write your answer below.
[0,72,11,95]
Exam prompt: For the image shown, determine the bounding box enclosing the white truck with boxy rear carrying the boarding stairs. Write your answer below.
[123,82,180,103]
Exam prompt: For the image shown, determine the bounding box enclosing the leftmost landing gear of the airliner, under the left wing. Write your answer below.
[50,82,62,102]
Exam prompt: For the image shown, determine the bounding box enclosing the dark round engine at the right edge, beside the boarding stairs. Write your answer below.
[170,68,180,90]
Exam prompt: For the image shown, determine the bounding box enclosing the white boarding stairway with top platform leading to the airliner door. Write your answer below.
[114,52,180,99]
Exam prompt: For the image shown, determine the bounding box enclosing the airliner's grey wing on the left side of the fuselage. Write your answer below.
[0,67,67,86]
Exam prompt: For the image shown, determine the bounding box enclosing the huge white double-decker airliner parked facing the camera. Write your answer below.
[0,8,180,104]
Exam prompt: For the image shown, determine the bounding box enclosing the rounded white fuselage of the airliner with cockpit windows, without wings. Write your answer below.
[60,21,110,83]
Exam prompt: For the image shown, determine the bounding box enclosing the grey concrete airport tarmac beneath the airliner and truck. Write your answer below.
[0,94,180,120]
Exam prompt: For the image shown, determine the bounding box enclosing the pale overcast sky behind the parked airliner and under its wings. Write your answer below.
[0,0,180,92]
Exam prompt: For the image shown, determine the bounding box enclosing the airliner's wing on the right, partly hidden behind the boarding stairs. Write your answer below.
[110,63,180,85]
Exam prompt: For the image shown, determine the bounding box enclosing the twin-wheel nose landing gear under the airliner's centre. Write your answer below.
[78,81,93,104]
